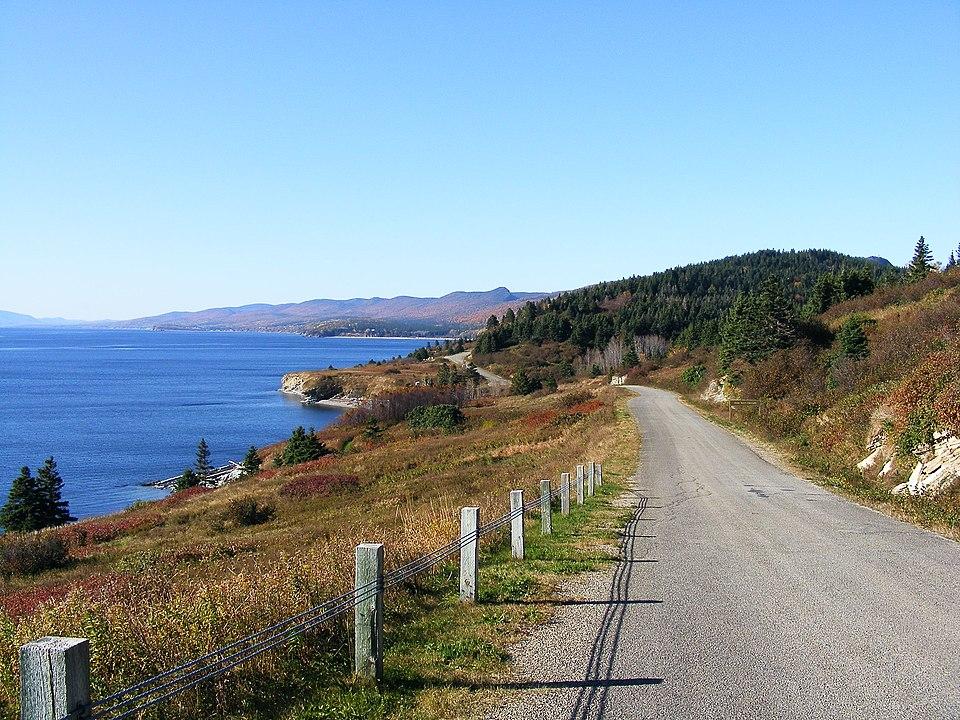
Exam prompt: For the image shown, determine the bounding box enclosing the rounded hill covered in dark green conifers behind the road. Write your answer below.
[476,250,898,354]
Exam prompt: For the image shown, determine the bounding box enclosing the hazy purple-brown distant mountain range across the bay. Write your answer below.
[93,287,550,335]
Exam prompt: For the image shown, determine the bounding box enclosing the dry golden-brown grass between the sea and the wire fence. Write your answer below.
[0,380,622,717]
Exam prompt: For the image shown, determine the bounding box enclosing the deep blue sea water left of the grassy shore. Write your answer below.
[0,329,424,517]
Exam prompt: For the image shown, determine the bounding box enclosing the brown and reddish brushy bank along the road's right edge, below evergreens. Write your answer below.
[645,273,960,539]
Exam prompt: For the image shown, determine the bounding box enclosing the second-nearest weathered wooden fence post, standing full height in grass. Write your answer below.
[353,543,383,681]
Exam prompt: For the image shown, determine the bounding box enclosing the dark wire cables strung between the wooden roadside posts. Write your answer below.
[73,488,561,720]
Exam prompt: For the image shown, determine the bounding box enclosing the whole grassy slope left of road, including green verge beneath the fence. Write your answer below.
[0,376,637,718]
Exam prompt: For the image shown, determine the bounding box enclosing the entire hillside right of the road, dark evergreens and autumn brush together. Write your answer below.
[474,245,960,534]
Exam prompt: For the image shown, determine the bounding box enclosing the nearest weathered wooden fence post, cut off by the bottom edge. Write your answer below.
[20,636,90,720]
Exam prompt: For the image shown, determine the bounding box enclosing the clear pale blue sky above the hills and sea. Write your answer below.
[0,0,960,318]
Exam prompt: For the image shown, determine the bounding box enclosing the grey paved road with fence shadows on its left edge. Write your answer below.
[491,388,960,720]
